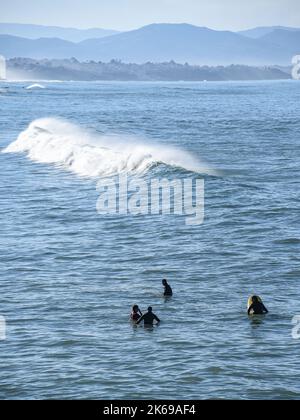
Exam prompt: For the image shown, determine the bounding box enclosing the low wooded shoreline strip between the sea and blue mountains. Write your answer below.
[7,58,291,82]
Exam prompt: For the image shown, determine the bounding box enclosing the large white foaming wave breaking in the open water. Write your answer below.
[3,118,217,177]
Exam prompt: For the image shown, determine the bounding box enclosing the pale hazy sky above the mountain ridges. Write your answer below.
[0,0,300,30]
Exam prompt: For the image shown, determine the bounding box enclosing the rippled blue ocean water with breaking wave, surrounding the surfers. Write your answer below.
[0,81,300,399]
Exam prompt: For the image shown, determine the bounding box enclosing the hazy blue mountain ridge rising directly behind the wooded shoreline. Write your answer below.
[0,24,300,66]
